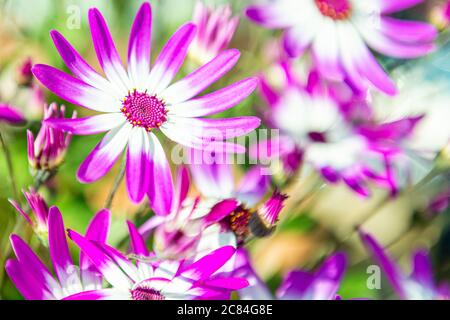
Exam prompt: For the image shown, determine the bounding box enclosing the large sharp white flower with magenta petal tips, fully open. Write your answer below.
[33,3,260,214]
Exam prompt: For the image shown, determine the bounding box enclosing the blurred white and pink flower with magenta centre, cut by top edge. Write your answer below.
[246,0,437,94]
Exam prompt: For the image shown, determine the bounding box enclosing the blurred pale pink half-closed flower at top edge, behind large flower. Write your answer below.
[189,0,239,65]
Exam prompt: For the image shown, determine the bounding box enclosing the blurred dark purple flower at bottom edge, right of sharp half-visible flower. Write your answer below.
[233,249,347,300]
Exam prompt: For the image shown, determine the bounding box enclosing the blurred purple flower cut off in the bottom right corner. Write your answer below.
[360,230,450,300]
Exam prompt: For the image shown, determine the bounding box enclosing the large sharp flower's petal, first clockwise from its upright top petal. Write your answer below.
[148,23,195,93]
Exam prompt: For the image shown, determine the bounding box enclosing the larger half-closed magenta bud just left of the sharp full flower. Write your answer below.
[27,103,76,182]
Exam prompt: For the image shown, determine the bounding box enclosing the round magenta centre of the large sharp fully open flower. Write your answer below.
[121,90,167,131]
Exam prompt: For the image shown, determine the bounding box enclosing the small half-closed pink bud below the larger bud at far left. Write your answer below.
[9,188,49,243]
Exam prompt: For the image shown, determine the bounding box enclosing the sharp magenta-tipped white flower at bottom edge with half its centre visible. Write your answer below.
[69,223,248,300]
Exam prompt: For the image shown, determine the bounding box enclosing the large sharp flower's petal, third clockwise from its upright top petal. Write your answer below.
[170,78,258,117]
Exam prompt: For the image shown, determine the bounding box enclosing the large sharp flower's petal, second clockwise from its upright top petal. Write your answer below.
[162,49,240,105]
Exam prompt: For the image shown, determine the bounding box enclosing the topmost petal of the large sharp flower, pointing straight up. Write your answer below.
[128,2,152,85]
